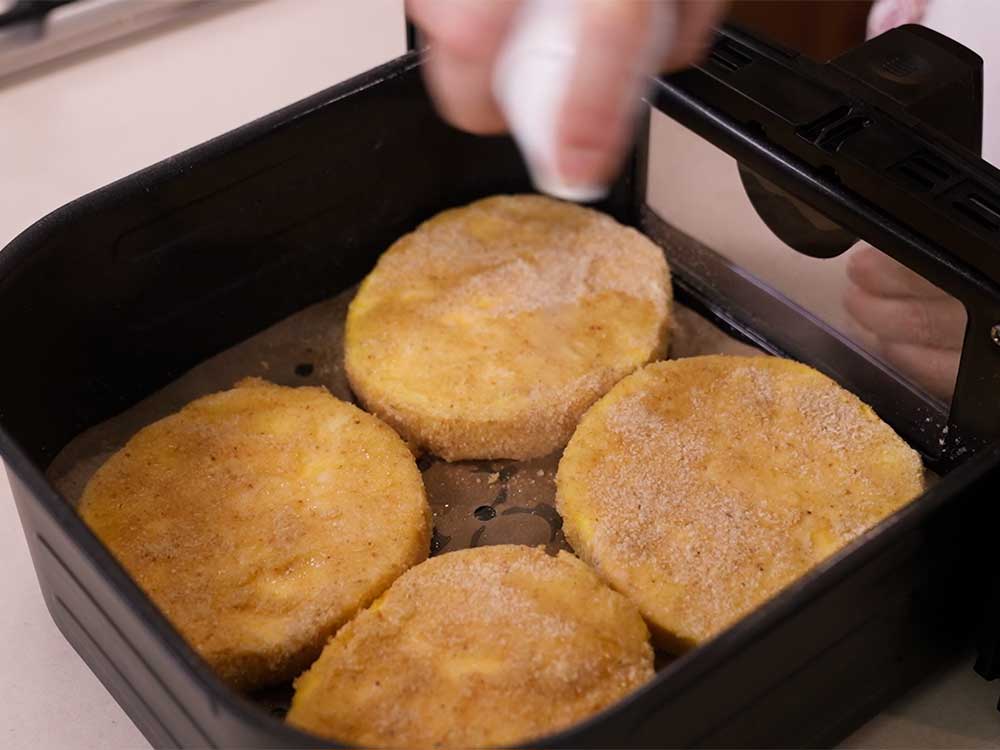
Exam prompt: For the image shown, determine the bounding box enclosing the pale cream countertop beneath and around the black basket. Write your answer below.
[0,0,1000,750]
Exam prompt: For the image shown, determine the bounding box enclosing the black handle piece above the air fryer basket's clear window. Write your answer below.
[651,26,1000,450]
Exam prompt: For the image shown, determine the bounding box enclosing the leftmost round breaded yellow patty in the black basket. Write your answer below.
[80,380,431,689]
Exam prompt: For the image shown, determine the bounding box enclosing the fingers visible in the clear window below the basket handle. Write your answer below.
[844,245,966,401]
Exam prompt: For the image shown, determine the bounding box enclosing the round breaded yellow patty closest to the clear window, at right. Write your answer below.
[557,356,924,651]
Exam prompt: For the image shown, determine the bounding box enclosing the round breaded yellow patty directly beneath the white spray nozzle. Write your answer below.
[345,195,671,461]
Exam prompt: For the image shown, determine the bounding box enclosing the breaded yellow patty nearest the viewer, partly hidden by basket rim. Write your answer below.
[288,545,653,748]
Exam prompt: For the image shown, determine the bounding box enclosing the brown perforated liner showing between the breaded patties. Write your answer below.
[48,287,760,716]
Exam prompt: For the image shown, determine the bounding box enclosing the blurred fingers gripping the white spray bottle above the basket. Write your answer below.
[407,0,726,185]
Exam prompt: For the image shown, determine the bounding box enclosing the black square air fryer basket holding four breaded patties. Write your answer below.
[0,22,1000,748]
